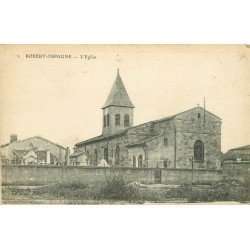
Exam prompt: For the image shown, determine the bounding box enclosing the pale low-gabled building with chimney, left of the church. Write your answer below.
[0,134,68,165]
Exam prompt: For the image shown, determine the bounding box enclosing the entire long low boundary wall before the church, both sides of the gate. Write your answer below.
[2,165,229,186]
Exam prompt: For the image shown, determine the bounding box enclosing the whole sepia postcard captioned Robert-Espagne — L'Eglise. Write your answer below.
[0,45,250,205]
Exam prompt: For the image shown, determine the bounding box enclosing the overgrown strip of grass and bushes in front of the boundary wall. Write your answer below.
[2,177,250,204]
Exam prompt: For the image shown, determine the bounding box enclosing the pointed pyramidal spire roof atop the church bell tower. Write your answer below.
[102,69,134,109]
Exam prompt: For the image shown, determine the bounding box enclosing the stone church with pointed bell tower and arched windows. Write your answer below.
[75,70,221,169]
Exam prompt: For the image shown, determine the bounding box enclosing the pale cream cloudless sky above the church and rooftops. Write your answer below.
[0,45,250,152]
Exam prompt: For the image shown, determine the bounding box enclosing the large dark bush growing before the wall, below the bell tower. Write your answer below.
[101,175,141,202]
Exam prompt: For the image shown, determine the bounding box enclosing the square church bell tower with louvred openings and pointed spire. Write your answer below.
[102,69,134,135]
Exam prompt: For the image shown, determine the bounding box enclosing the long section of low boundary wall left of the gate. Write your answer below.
[2,165,154,186]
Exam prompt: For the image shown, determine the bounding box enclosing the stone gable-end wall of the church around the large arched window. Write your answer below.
[174,108,221,169]
